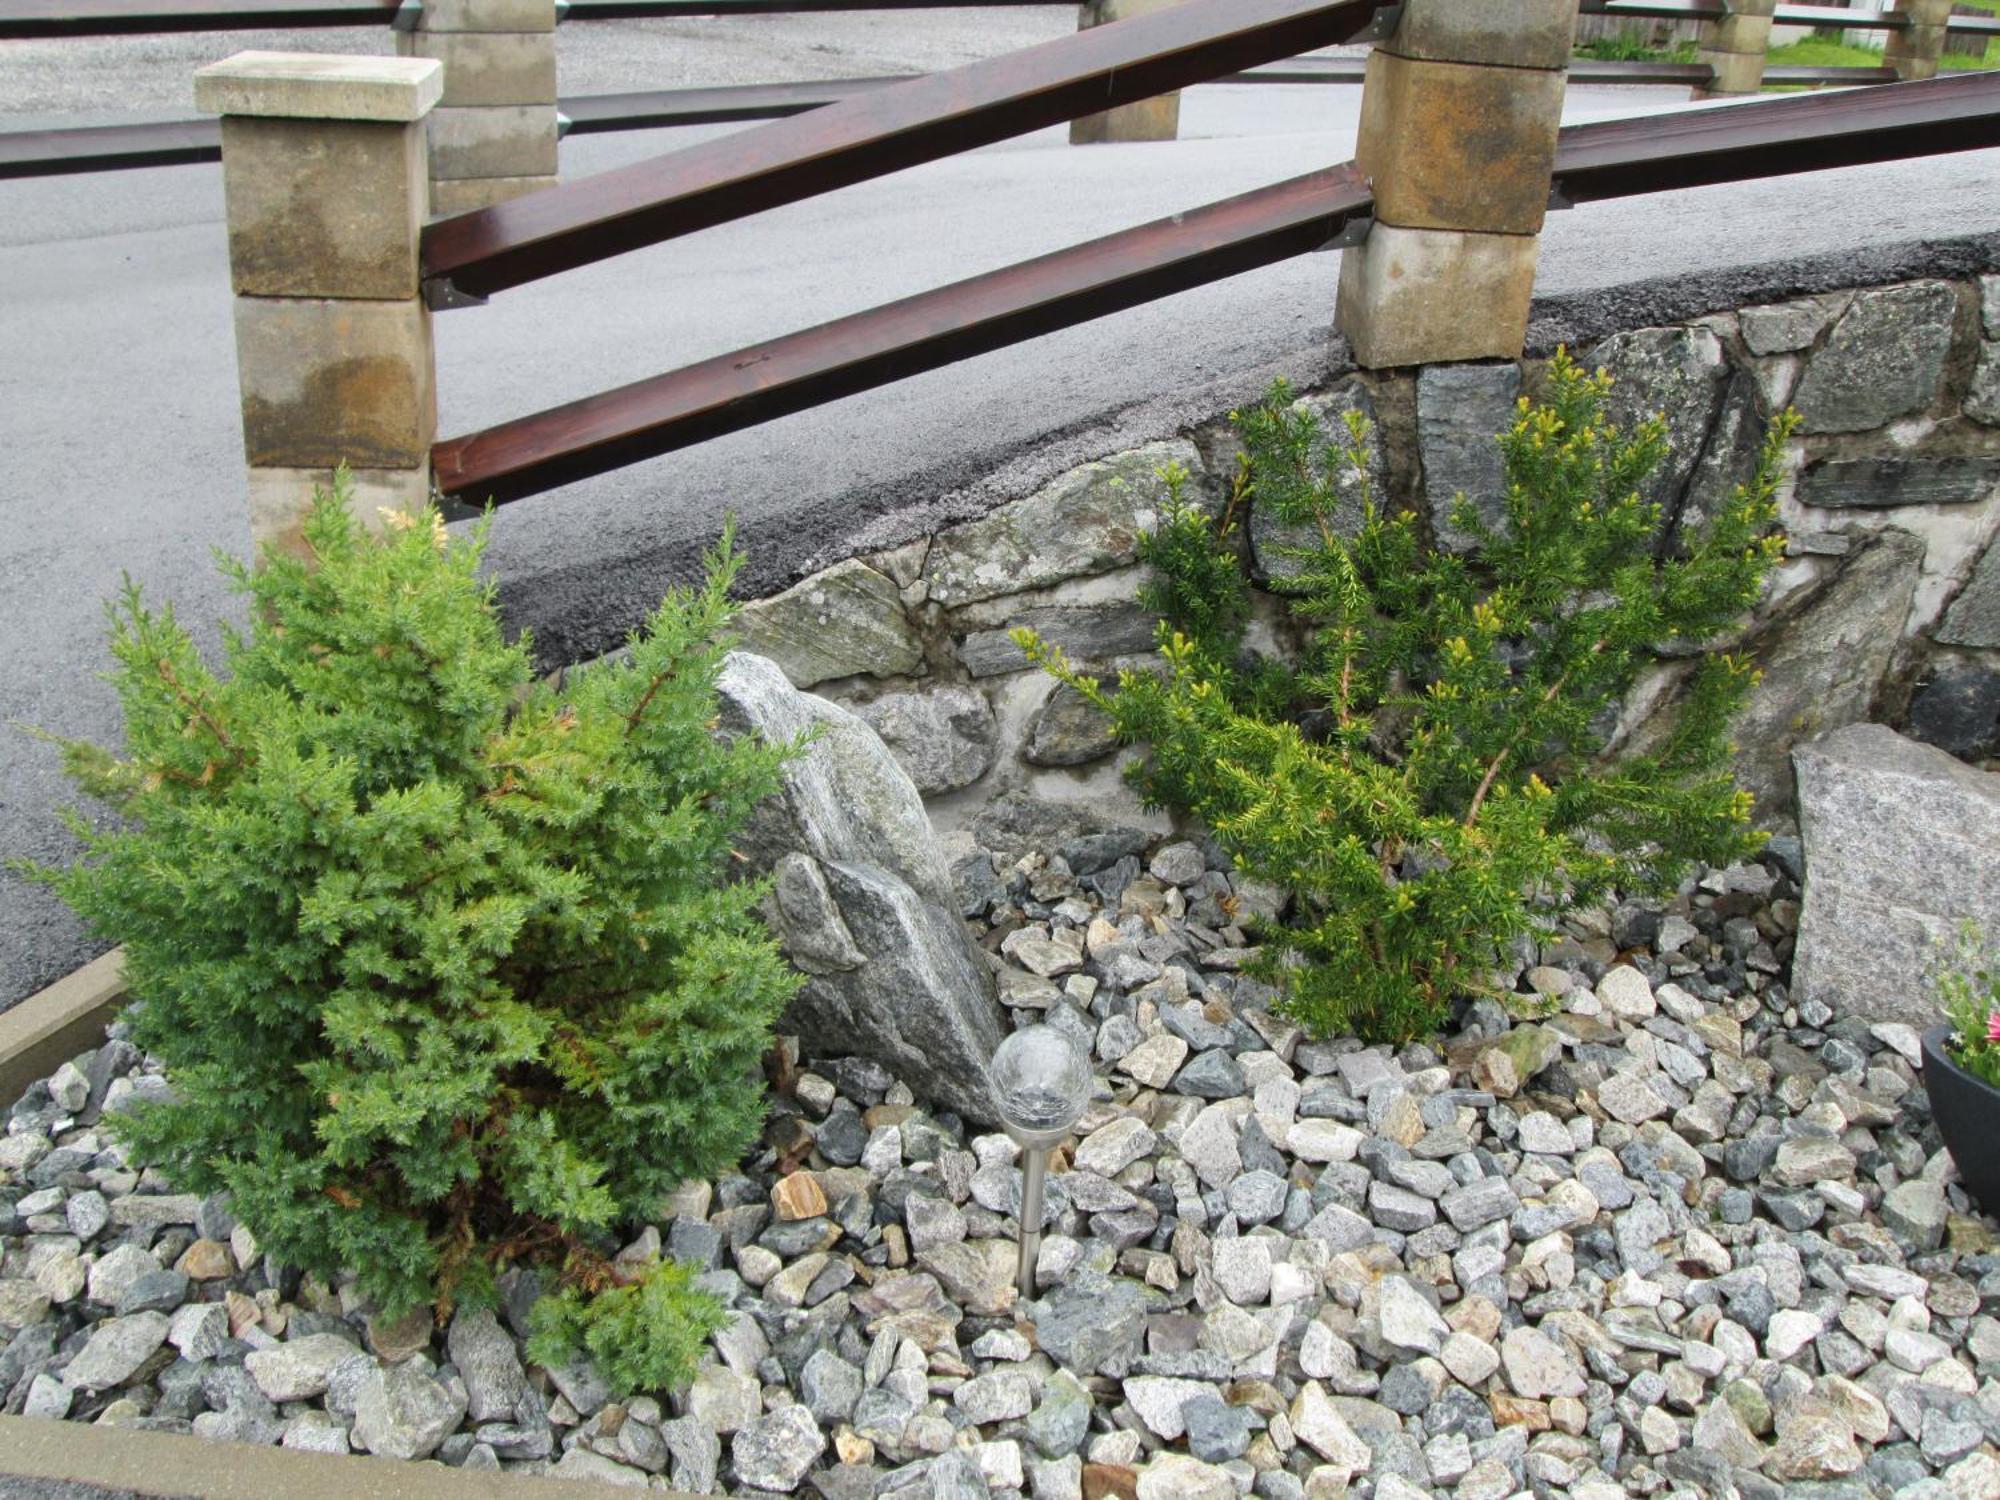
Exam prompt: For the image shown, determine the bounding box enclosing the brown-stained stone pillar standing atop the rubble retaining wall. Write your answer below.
[1334,0,1576,368]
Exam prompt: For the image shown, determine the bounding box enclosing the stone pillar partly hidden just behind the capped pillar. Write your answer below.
[396,0,556,214]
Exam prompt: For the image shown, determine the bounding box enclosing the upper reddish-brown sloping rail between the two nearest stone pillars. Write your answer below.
[424,0,1390,300]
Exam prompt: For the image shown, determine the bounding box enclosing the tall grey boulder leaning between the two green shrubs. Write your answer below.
[718,652,1002,1122]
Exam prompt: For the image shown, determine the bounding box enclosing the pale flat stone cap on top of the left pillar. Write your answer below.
[194,52,444,124]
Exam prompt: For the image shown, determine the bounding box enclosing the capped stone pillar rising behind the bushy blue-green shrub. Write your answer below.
[194,52,442,550]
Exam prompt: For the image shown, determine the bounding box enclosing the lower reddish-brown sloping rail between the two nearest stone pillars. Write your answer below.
[432,166,1372,504]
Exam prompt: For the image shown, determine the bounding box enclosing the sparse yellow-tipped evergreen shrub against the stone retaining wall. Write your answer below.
[1016,354,1792,1040]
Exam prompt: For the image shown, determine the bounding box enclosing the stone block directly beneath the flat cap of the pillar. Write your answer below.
[222,116,426,300]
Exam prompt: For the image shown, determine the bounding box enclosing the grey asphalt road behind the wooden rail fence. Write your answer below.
[0,6,2000,1008]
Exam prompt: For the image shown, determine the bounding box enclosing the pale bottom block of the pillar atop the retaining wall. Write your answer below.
[1338,224,1540,370]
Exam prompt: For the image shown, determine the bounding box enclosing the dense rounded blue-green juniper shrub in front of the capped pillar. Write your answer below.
[36,482,798,1388]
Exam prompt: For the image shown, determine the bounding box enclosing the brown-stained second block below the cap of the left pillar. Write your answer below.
[236,298,438,468]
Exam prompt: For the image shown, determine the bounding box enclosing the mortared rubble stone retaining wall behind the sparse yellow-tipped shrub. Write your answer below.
[720,276,2000,848]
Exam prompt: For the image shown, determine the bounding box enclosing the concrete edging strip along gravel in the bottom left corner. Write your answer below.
[0,1416,672,1500]
